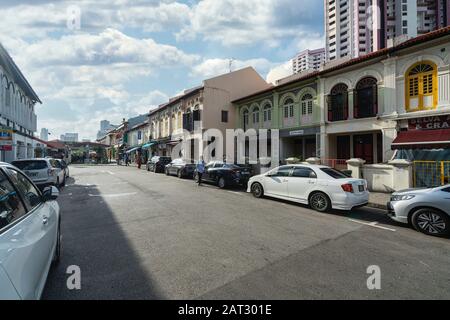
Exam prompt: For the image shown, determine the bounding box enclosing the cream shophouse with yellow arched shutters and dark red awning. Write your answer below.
[319,27,450,164]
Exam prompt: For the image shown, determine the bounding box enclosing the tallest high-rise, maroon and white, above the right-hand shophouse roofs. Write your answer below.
[325,0,450,61]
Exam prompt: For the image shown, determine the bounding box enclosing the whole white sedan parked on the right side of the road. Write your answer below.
[247,164,369,212]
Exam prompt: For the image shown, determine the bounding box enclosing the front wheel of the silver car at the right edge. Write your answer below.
[411,208,450,237]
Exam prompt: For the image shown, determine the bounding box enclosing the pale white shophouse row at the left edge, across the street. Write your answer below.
[0,44,42,162]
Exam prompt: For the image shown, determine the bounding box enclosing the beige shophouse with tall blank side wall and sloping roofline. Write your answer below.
[144,67,271,160]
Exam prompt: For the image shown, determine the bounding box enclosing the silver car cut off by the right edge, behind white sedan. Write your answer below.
[387,185,450,236]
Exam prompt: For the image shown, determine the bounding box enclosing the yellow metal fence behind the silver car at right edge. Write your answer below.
[413,161,450,187]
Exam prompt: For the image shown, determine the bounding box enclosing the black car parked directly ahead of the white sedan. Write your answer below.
[194,161,250,189]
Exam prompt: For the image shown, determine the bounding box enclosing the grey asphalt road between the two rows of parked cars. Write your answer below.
[43,166,450,299]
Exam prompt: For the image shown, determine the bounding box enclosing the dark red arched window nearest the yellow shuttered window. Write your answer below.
[353,77,378,118]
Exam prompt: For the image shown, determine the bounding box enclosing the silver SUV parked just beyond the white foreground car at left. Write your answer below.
[11,158,66,189]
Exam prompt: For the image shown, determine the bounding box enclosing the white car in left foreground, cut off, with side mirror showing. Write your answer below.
[0,163,61,300]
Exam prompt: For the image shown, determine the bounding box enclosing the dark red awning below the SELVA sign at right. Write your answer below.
[391,129,450,150]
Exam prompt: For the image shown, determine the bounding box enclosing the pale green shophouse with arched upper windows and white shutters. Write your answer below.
[233,75,321,162]
